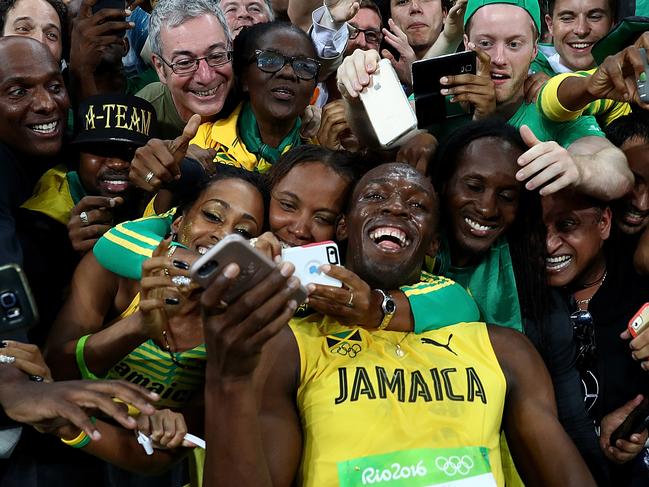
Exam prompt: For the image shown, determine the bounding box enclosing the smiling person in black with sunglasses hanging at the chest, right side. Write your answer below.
[543,190,649,486]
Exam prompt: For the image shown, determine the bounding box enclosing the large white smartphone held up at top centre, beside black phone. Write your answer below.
[361,59,417,148]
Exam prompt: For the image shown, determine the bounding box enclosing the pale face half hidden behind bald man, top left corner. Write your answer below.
[2,0,63,61]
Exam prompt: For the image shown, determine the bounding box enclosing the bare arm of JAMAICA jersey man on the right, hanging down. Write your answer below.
[489,326,595,487]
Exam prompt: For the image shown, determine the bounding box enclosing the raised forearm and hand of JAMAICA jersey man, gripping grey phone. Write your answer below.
[201,263,302,487]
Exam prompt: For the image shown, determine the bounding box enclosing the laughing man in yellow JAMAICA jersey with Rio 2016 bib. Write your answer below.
[202,164,594,487]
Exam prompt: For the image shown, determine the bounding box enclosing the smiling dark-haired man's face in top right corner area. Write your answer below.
[545,0,613,71]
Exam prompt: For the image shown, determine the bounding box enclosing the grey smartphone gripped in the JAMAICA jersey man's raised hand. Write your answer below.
[189,235,307,305]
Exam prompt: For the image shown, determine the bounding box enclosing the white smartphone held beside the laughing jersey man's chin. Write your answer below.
[282,240,343,287]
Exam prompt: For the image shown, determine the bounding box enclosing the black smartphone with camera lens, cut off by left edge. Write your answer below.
[0,264,38,336]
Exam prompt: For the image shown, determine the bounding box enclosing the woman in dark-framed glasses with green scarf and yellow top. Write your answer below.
[190,22,320,172]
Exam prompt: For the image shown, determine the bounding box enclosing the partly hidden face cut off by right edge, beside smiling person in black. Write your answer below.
[613,144,649,234]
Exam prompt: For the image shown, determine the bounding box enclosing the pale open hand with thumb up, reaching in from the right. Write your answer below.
[516,125,582,196]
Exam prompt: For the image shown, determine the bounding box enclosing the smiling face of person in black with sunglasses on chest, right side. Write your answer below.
[543,191,611,287]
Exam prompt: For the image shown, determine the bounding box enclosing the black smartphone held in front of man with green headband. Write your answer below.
[412,51,477,128]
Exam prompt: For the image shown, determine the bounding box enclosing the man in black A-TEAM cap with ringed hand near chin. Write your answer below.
[18,95,156,341]
